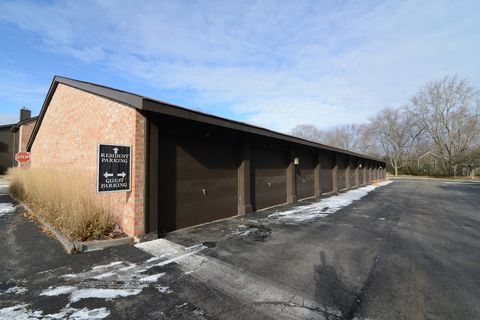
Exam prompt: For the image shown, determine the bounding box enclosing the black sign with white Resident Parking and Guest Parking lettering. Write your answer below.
[97,144,132,192]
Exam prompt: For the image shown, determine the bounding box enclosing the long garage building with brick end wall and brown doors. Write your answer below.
[27,76,385,235]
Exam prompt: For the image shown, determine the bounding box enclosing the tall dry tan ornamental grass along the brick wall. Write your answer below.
[7,168,113,240]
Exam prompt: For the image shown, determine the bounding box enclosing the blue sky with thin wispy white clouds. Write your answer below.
[0,0,480,132]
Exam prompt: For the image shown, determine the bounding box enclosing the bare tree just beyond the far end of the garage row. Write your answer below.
[368,108,423,175]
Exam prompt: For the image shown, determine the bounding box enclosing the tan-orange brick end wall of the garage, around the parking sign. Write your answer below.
[31,84,145,235]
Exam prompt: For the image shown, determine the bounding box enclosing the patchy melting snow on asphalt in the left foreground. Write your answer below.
[0,244,199,320]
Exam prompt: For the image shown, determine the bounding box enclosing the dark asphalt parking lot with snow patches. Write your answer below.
[0,180,480,319]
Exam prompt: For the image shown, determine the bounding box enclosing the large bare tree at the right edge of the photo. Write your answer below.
[411,76,480,174]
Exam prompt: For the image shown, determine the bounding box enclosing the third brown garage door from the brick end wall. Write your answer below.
[295,149,317,199]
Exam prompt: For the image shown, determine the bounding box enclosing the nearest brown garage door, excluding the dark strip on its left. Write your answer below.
[175,135,238,229]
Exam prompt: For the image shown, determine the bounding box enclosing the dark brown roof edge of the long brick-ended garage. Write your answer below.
[27,76,385,163]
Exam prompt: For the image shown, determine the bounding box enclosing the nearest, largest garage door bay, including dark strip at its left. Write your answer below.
[158,136,238,232]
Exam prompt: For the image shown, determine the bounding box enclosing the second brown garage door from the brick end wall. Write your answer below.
[251,147,287,210]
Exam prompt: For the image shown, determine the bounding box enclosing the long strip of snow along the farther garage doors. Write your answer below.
[268,181,392,223]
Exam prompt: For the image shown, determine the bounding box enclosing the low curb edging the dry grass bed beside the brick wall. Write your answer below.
[10,194,134,254]
